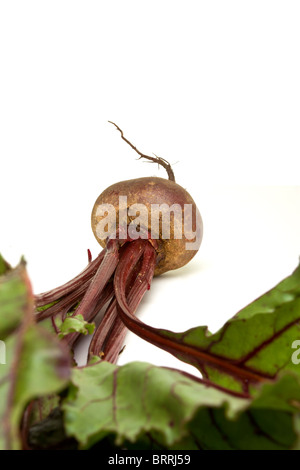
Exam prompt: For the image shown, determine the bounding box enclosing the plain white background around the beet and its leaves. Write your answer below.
[0,0,300,370]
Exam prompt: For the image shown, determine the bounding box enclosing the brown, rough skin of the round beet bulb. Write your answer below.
[92,177,203,276]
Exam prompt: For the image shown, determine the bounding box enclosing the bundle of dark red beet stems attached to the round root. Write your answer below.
[35,235,158,363]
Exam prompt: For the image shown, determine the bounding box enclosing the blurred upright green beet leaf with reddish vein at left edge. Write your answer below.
[0,262,70,450]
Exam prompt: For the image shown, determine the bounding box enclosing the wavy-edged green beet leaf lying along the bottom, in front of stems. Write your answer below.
[63,361,300,449]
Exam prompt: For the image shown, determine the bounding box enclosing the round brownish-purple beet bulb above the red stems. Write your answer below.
[92,177,203,276]
